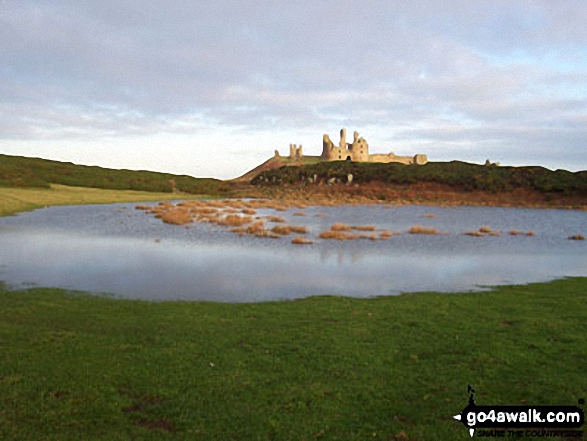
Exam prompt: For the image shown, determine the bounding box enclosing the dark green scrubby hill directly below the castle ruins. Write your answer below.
[251,161,587,196]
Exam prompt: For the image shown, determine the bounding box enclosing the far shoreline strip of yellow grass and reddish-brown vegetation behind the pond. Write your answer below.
[0,184,587,216]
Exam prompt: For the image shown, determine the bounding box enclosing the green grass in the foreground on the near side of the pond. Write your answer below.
[0,278,587,440]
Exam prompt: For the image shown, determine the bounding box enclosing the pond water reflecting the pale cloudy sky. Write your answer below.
[0,205,587,302]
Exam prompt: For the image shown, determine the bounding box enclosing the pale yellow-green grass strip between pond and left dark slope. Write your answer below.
[0,184,211,216]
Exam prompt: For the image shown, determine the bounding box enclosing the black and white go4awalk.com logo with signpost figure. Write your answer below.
[453,385,585,438]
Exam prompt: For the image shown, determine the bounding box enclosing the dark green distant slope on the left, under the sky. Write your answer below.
[0,155,231,194]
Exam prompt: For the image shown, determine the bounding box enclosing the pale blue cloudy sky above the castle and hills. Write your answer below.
[0,0,587,179]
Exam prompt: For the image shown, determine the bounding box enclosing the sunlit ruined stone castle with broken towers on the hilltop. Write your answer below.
[275,129,428,165]
